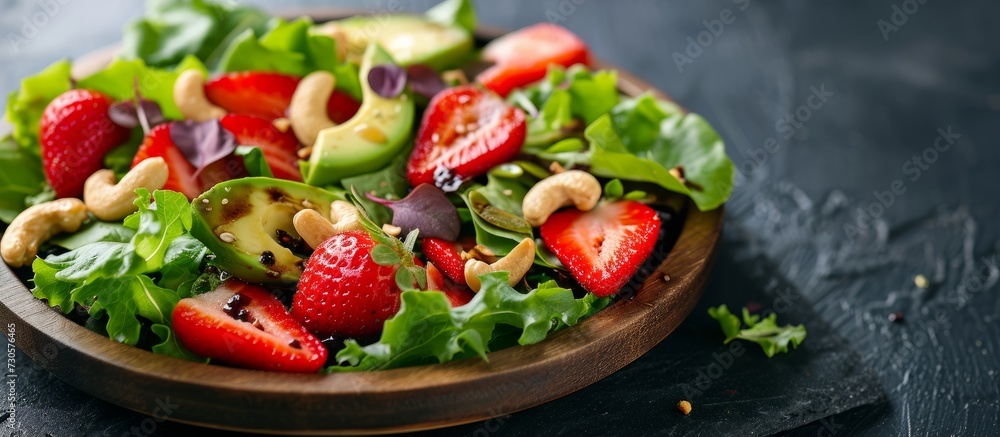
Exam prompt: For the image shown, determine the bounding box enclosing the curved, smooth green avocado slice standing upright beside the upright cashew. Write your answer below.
[302,44,414,186]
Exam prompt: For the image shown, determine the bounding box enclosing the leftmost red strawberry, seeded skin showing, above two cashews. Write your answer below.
[38,90,129,197]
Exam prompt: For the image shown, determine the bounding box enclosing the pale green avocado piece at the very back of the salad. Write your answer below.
[311,15,474,70]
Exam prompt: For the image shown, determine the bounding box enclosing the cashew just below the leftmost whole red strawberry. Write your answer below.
[83,157,170,222]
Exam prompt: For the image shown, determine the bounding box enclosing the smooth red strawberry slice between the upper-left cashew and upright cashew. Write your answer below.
[205,71,299,120]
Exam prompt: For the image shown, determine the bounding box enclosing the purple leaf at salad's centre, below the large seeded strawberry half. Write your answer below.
[368,184,462,241]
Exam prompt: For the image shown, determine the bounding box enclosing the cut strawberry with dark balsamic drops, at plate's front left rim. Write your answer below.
[172,280,328,373]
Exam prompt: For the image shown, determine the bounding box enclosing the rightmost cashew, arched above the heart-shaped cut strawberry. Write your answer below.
[521,170,601,227]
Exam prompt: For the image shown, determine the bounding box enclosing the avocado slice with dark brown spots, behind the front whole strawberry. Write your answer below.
[191,177,339,284]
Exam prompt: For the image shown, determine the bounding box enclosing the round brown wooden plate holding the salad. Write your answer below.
[0,11,723,434]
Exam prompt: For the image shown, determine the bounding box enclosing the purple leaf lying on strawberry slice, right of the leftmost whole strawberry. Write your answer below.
[170,120,239,177]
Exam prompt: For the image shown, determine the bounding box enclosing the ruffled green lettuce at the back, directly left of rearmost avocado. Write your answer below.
[219,17,361,100]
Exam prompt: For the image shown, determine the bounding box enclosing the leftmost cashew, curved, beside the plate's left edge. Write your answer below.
[0,198,87,267]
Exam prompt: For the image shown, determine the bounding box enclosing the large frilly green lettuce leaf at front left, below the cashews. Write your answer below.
[32,189,208,360]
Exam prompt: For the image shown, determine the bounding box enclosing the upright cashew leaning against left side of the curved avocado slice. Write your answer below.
[288,71,337,146]
